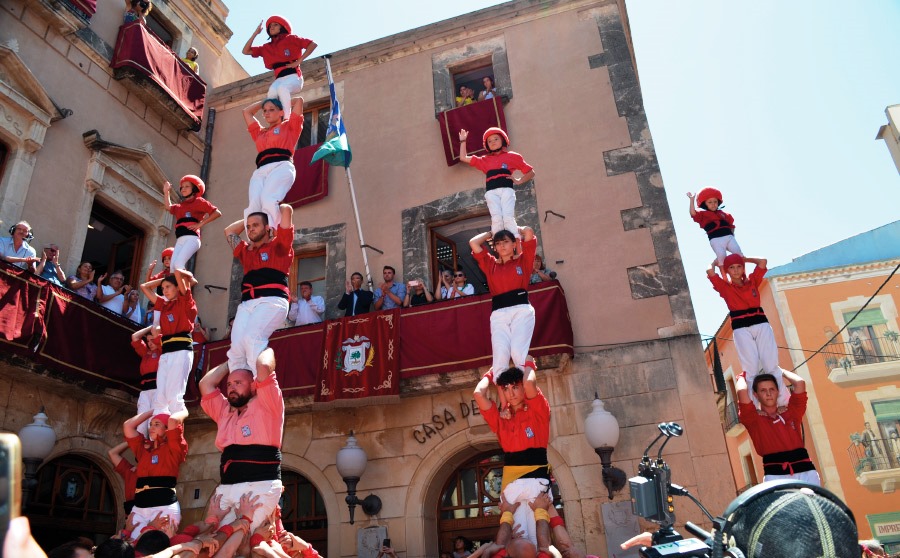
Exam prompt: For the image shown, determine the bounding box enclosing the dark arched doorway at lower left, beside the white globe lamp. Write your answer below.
[25,455,118,548]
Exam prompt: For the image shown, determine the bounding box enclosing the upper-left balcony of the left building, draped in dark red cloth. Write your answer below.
[110,22,206,130]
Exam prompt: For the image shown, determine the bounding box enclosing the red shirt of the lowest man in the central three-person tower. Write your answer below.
[481,388,550,452]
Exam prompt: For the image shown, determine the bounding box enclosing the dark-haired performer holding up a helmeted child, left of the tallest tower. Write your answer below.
[141,268,197,415]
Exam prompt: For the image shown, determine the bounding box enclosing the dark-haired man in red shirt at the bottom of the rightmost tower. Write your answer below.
[726,372,822,486]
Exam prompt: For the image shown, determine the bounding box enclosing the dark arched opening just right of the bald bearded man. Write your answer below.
[279,469,328,556]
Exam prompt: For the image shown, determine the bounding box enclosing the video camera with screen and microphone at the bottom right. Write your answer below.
[628,422,713,558]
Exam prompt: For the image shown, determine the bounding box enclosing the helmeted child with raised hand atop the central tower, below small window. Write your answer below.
[459,128,534,240]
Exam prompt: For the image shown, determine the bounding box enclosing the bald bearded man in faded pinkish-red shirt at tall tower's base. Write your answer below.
[200,350,290,532]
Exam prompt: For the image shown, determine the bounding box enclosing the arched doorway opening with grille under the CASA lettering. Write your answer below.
[437,450,564,552]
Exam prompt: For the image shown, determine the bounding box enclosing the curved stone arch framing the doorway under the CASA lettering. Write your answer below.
[405,426,584,556]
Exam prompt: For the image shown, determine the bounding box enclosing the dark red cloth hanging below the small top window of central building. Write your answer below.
[438,97,506,167]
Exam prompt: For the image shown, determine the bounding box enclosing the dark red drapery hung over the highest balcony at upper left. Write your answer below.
[110,22,206,125]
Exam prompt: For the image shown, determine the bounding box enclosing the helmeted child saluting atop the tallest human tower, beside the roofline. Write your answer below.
[242,15,317,120]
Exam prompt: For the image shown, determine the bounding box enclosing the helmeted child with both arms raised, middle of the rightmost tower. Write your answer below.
[706,254,791,407]
